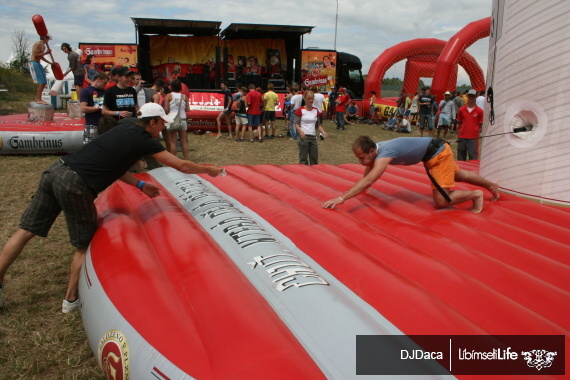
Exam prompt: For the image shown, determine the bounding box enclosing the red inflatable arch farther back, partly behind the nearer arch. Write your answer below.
[364,38,485,116]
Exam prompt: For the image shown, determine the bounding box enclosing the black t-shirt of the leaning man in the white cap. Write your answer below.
[62,117,165,193]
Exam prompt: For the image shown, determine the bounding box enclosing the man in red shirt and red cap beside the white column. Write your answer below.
[457,90,483,161]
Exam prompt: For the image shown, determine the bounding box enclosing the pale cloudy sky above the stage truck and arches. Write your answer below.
[0,0,492,73]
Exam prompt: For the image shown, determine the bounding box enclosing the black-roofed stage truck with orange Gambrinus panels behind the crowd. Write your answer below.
[80,18,364,129]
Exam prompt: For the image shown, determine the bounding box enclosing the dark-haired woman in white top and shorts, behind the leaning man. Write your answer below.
[164,79,190,160]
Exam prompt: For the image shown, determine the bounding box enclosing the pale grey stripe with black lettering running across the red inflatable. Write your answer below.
[150,168,450,379]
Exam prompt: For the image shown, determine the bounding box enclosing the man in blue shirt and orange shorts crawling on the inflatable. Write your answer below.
[322,136,500,214]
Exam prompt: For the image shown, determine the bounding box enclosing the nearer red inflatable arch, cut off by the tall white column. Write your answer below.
[431,17,491,99]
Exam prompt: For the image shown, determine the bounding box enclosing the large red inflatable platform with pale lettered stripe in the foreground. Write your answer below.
[80,162,570,380]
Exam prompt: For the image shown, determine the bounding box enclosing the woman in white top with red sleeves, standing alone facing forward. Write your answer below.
[295,91,328,165]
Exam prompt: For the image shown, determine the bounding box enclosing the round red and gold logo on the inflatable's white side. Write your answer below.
[99,330,129,380]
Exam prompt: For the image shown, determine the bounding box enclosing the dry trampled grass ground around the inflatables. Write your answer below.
[0,77,455,379]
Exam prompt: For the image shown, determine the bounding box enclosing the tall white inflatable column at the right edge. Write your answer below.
[481,0,570,205]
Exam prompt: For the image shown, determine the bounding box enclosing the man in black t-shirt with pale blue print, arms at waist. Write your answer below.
[103,67,138,120]
